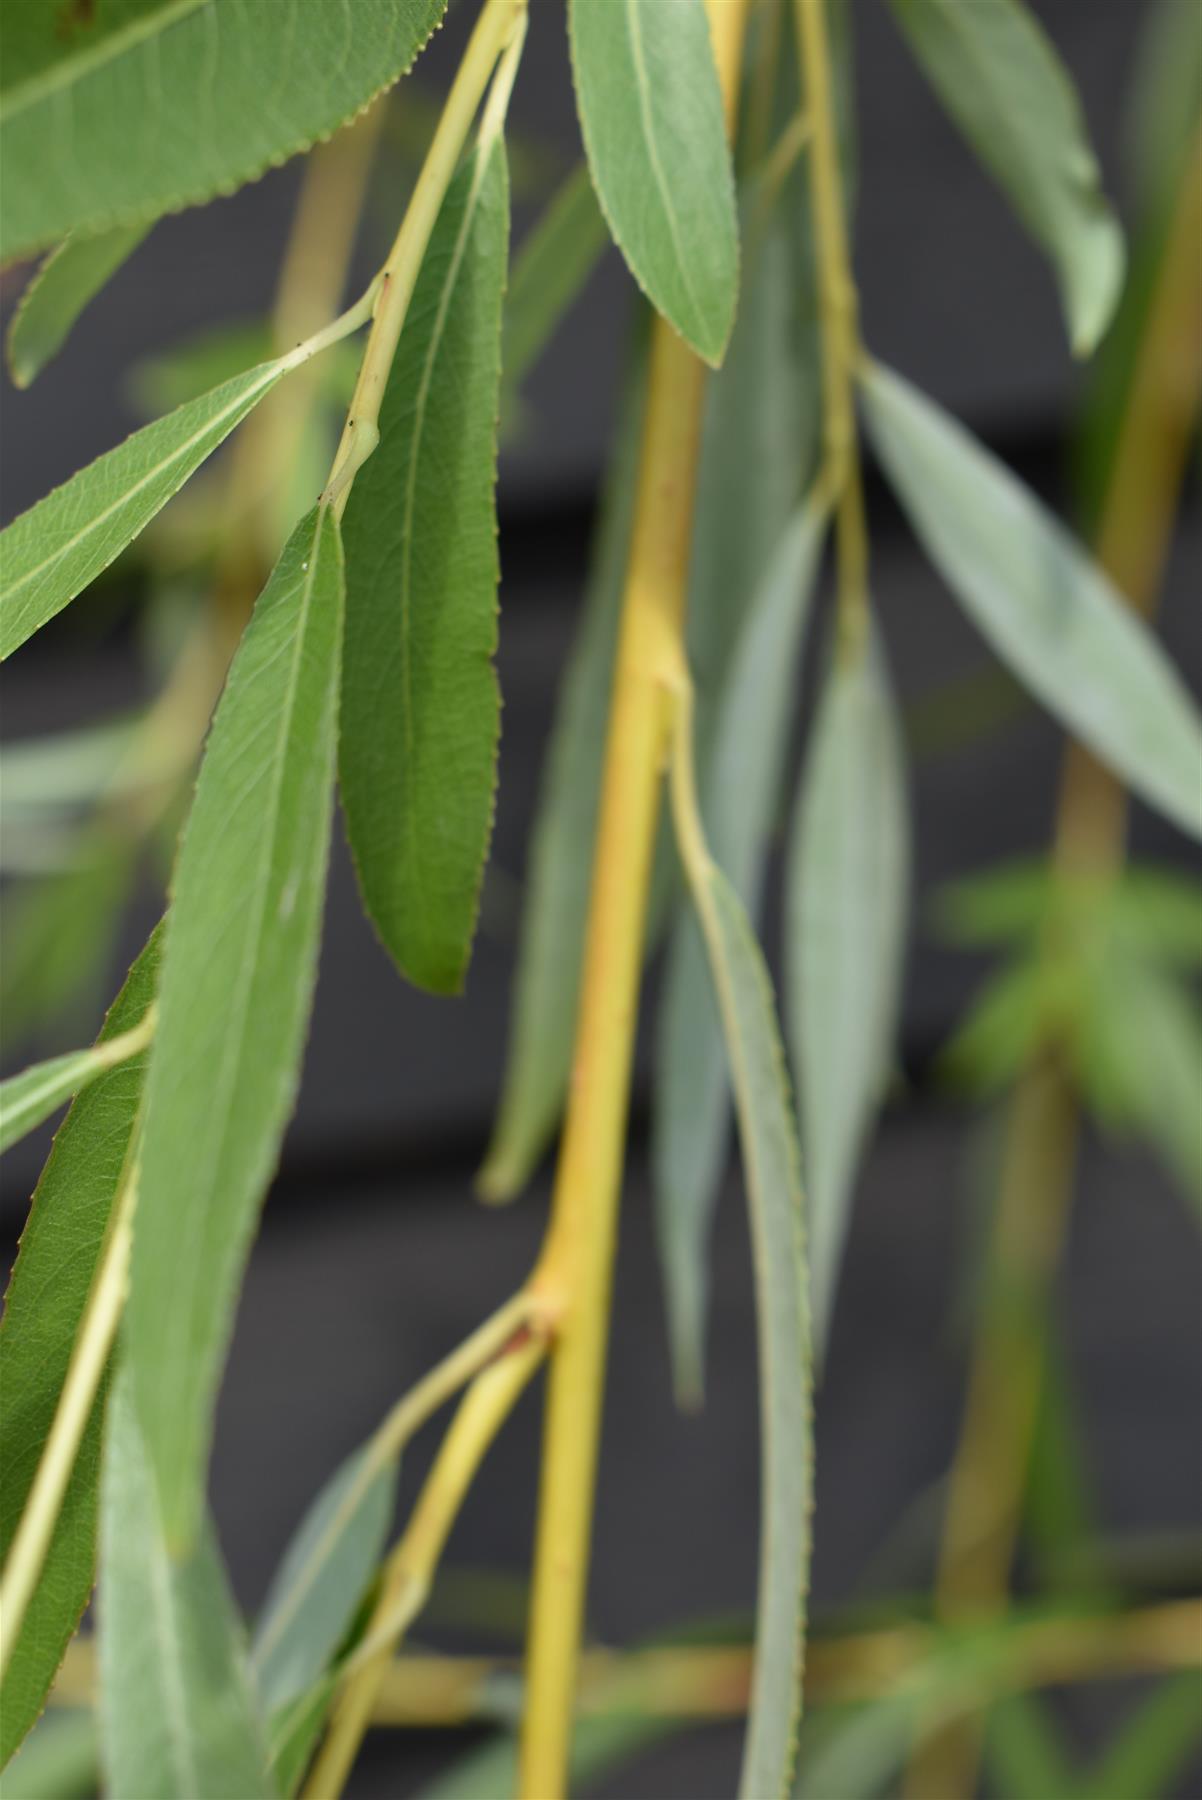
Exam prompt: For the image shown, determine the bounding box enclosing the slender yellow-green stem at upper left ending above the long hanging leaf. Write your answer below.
[326,0,525,518]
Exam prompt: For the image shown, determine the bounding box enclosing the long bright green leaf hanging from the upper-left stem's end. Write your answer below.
[126,508,344,1552]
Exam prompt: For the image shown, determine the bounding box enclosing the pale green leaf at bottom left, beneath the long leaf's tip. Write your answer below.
[99,1370,272,1800]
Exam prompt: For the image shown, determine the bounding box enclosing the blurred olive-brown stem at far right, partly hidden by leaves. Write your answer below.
[909,119,1202,1800]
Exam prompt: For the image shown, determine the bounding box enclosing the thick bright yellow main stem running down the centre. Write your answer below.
[518,0,745,1800]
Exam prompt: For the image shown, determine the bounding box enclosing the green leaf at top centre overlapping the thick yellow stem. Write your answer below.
[569,0,740,364]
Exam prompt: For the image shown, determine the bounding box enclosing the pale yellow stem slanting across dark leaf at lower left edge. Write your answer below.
[0,1130,137,1678]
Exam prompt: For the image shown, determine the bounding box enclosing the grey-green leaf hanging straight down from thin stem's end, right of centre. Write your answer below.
[786,641,909,1348]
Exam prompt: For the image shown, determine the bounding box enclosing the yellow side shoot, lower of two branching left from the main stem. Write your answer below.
[304,1332,547,1800]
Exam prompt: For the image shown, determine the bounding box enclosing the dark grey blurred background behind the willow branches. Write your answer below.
[0,0,1202,1800]
